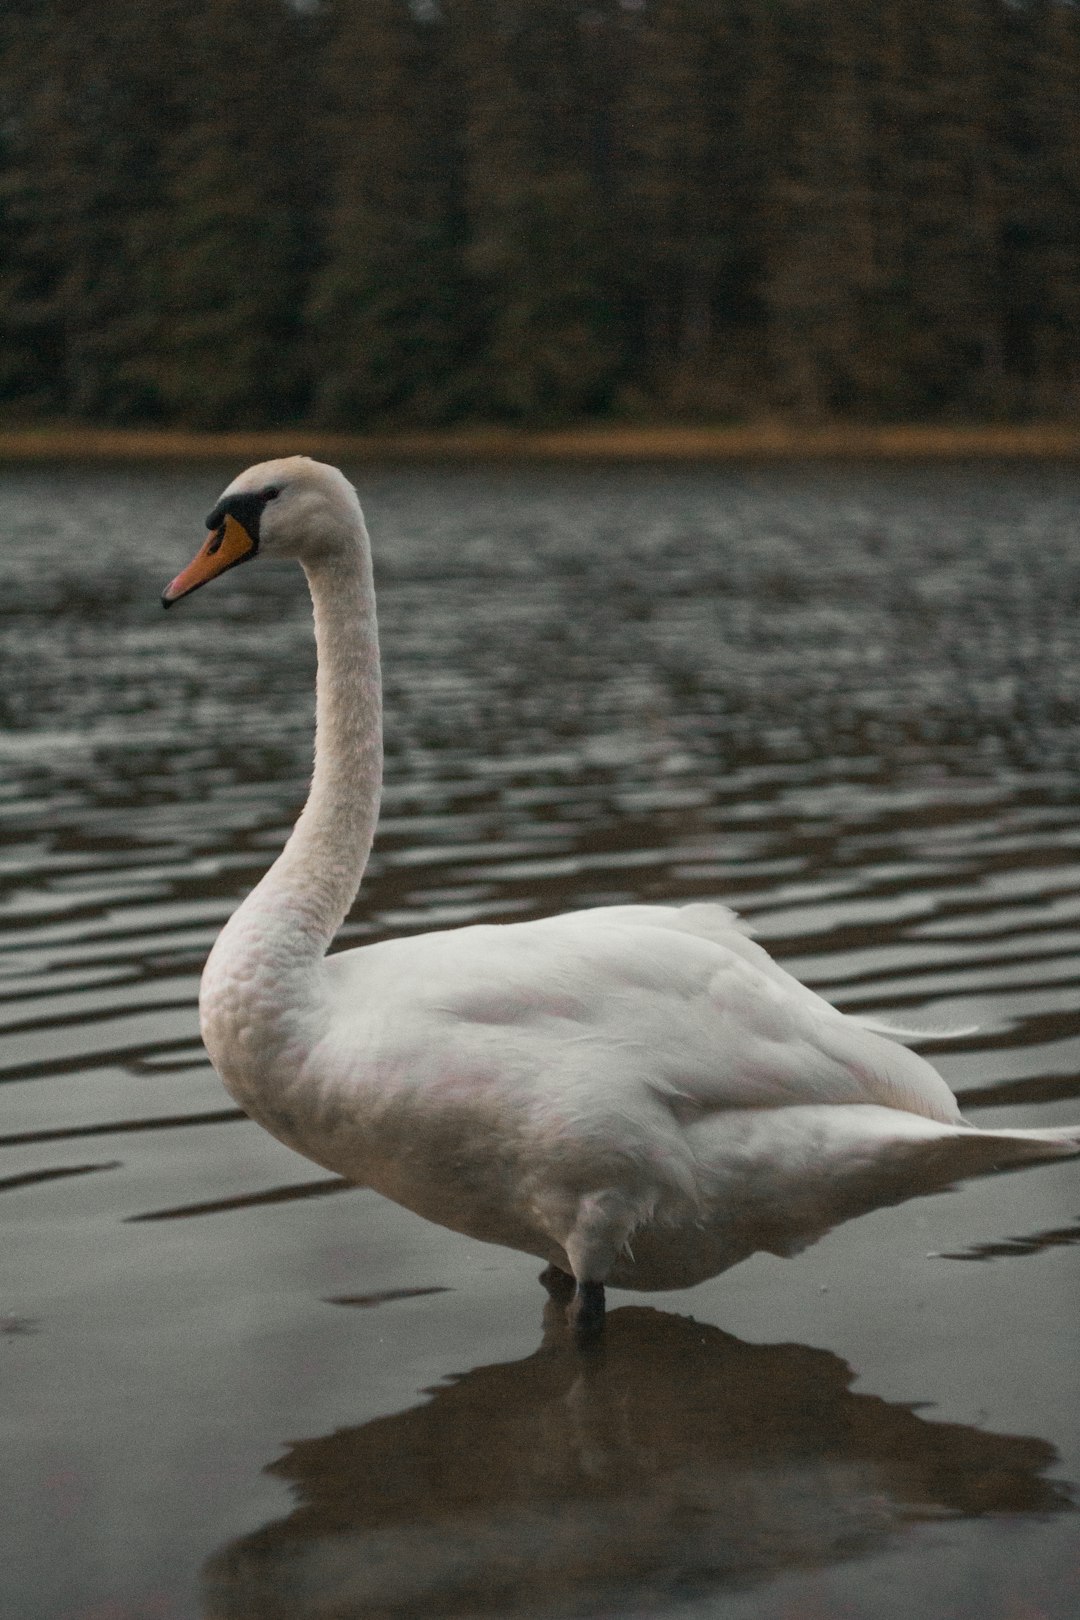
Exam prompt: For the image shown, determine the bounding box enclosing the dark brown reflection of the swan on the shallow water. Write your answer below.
[206,1307,1069,1620]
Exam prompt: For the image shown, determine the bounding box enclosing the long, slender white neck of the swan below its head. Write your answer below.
[201,520,382,1079]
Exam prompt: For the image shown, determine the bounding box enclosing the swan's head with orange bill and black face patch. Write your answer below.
[162,455,363,608]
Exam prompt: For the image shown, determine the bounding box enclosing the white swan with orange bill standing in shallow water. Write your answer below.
[162,455,1080,1345]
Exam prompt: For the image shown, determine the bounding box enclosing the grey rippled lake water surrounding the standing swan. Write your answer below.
[0,467,1080,1620]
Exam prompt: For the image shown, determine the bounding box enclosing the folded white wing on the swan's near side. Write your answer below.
[327,907,960,1121]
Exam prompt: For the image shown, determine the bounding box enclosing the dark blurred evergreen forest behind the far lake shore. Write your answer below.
[0,0,1080,428]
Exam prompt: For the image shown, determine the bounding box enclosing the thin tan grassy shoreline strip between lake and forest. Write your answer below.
[0,423,1080,463]
